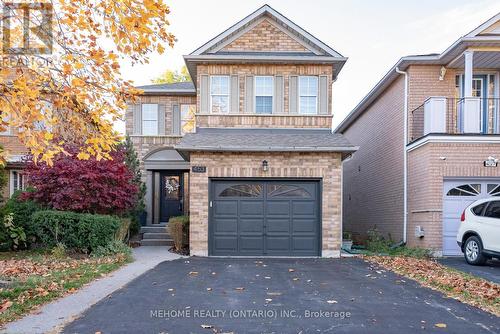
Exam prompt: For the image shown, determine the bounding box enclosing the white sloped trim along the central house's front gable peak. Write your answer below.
[191,5,343,57]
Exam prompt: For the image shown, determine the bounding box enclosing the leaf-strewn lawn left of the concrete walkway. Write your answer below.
[0,251,130,325]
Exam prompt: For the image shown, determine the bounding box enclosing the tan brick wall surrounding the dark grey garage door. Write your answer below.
[189,152,342,257]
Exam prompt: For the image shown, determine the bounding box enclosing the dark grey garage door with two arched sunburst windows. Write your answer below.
[209,180,321,256]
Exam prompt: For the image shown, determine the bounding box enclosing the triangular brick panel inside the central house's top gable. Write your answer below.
[221,19,308,52]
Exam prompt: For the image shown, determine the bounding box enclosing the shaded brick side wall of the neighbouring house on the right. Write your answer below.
[343,76,404,241]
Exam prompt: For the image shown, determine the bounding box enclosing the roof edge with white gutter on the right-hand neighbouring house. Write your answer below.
[334,13,500,133]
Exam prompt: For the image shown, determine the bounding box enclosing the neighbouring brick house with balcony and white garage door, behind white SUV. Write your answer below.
[336,14,500,255]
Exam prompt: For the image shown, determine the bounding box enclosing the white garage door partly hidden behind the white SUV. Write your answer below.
[443,179,500,255]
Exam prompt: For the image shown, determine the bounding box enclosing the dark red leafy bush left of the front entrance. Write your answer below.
[23,148,139,214]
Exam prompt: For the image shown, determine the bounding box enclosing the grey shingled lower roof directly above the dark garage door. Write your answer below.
[175,128,357,152]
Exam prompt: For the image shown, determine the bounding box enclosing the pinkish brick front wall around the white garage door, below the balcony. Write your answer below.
[408,142,500,252]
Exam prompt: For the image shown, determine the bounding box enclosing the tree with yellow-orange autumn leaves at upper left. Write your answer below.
[0,0,175,164]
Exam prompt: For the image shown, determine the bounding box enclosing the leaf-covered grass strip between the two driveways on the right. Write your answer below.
[365,255,500,316]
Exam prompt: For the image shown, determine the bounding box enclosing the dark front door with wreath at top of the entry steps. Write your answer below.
[160,173,184,223]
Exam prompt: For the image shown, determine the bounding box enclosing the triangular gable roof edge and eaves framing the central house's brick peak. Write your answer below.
[184,5,347,78]
